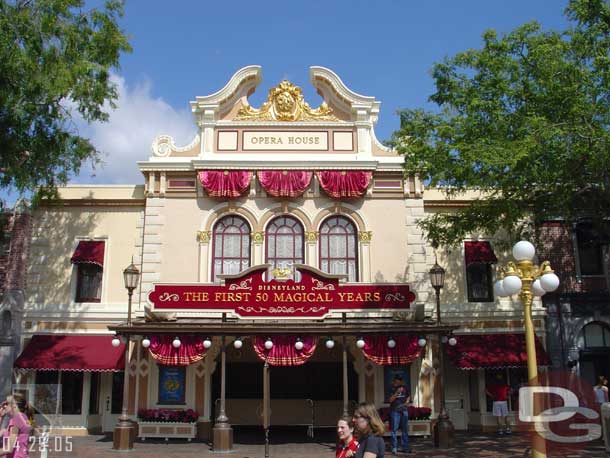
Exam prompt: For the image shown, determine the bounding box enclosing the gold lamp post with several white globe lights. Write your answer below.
[494,240,559,458]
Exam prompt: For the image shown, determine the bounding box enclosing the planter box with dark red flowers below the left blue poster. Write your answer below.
[138,409,199,441]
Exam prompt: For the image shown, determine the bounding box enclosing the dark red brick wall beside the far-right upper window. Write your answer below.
[538,222,607,293]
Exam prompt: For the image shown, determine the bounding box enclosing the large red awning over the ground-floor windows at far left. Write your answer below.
[15,335,125,371]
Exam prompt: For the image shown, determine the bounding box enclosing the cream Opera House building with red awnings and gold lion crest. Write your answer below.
[16,66,545,437]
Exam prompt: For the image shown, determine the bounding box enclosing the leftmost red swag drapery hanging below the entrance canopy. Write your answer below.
[148,335,207,366]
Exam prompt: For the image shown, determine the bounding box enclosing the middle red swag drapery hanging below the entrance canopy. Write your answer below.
[254,336,316,366]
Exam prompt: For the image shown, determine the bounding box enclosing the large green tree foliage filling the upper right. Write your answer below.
[392,0,610,246]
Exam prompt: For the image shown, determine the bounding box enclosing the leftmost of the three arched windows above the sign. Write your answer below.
[212,215,250,281]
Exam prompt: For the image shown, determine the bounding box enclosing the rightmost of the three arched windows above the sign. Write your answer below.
[320,216,358,282]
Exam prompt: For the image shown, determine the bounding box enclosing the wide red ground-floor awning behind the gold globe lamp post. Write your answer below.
[445,334,550,369]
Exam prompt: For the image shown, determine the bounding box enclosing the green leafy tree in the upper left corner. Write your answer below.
[0,0,131,201]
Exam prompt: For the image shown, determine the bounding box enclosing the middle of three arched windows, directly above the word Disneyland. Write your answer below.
[266,216,305,280]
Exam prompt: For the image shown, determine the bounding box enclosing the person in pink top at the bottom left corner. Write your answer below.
[0,393,34,458]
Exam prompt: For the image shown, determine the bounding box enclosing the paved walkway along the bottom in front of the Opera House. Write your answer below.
[30,432,610,458]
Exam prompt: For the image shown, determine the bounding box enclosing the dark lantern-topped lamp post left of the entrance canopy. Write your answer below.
[112,260,140,450]
